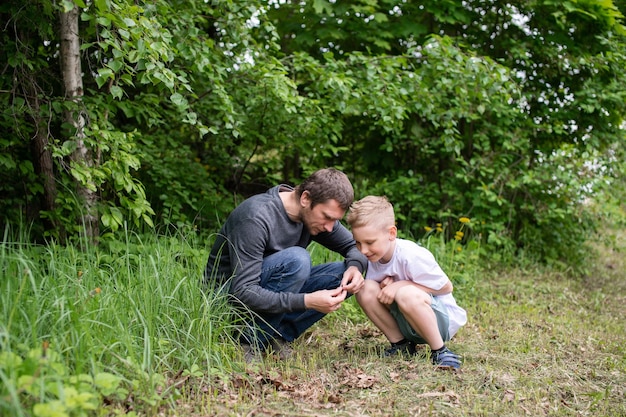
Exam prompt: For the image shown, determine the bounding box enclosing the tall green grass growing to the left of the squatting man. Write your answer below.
[0,226,243,416]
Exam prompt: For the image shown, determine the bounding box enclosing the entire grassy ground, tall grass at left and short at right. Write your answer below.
[0,226,626,416]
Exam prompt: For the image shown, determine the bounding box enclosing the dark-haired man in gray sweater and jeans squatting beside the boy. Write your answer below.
[204,168,367,362]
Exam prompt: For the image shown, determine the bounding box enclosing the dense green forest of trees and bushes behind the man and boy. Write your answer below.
[0,0,626,414]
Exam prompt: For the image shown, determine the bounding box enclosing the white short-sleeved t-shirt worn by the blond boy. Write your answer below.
[366,239,467,337]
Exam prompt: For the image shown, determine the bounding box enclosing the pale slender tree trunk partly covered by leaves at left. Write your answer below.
[61,7,99,243]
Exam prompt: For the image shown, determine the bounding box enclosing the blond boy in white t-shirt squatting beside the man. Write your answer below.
[347,196,467,370]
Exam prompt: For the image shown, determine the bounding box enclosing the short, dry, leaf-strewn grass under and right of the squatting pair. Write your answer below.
[193,231,626,416]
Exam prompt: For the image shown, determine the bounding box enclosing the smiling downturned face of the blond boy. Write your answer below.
[352,225,398,263]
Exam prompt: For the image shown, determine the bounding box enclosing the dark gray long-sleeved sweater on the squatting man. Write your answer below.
[204,185,367,313]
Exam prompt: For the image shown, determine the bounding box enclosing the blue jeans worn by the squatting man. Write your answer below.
[242,246,345,349]
